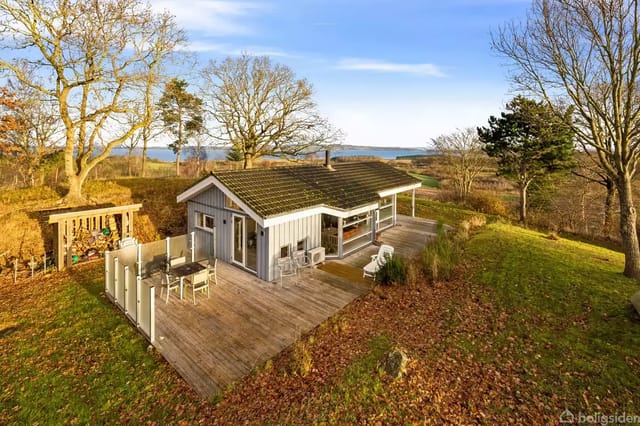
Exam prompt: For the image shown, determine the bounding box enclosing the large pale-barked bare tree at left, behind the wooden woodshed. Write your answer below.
[0,0,182,204]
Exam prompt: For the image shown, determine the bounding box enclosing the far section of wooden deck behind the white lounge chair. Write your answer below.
[336,215,437,269]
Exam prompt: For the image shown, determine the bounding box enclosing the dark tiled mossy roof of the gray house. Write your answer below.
[214,162,419,218]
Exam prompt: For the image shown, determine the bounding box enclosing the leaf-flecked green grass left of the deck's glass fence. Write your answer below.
[0,268,205,424]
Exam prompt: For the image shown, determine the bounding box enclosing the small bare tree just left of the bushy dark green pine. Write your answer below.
[431,127,488,200]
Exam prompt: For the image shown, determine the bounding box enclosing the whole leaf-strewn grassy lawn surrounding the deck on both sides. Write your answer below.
[0,195,640,424]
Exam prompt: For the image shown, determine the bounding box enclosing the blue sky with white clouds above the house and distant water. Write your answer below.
[151,0,530,148]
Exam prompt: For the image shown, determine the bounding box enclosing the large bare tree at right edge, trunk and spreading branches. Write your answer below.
[493,0,640,278]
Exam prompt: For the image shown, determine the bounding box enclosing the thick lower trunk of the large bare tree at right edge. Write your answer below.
[617,175,640,278]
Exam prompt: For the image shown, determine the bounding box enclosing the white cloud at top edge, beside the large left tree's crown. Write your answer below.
[151,0,264,36]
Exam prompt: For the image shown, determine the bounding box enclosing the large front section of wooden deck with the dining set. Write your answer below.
[154,262,368,398]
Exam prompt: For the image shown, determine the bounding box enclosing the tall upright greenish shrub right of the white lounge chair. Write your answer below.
[422,223,460,281]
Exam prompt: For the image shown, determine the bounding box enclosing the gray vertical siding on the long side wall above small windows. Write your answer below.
[268,214,321,281]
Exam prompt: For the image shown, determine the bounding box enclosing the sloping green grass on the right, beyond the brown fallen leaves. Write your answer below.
[457,224,640,412]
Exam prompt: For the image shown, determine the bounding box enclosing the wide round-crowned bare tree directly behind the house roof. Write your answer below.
[202,55,341,168]
